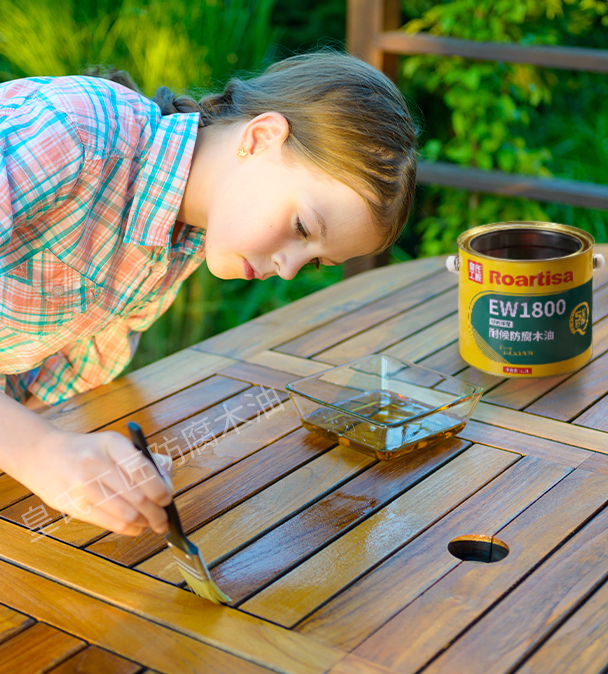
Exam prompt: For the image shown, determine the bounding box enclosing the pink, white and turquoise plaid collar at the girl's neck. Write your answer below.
[124,112,199,251]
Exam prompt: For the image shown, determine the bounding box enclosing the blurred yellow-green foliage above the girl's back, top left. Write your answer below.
[0,0,276,89]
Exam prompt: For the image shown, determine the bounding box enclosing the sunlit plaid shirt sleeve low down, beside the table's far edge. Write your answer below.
[28,321,141,405]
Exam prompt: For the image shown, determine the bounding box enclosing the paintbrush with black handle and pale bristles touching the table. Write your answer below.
[127,421,230,604]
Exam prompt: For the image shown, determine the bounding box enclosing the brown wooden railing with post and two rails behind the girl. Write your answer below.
[347,0,608,275]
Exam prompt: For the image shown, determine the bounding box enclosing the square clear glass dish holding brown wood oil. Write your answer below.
[286,355,483,460]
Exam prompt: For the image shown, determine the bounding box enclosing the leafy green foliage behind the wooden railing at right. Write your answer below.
[402,0,608,255]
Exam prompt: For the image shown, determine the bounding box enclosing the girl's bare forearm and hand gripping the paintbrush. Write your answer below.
[0,393,171,536]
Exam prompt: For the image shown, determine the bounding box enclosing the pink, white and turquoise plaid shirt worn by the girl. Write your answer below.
[0,77,205,405]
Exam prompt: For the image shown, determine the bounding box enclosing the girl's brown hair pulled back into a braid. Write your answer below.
[87,52,417,252]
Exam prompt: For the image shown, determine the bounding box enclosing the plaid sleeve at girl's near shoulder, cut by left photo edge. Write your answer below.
[0,97,84,252]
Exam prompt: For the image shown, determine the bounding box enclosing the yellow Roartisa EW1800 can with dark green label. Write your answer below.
[446,222,604,378]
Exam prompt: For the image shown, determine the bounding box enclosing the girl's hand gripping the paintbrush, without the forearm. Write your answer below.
[21,428,173,536]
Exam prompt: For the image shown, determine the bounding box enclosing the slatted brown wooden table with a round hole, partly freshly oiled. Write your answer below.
[0,247,608,674]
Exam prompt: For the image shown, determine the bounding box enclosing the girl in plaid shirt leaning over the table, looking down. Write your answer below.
[0,53,416,536]
